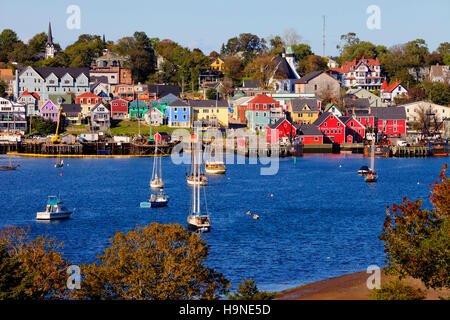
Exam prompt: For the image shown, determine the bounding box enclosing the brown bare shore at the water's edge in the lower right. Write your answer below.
[274,272,450,300]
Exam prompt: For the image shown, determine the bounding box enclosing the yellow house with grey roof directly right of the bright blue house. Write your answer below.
[189,100,229,128]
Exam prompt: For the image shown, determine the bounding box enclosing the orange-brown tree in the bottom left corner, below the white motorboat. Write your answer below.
[0,227,68,299]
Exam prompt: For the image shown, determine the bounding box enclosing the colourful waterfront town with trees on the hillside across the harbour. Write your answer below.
[0,23,450,158]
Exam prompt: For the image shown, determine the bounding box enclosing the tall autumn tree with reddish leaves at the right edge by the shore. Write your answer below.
[380,165,450,288]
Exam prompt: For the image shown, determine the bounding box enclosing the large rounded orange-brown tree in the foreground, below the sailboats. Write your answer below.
[71,222,230,300]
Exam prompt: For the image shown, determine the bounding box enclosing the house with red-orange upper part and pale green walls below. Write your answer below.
[245,94,282,132]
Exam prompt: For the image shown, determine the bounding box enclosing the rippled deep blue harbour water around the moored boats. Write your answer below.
[0,155,448,290]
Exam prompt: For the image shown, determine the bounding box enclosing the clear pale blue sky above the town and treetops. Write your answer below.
[0,0,450,55]
